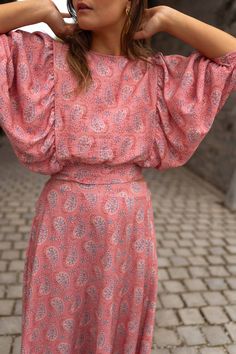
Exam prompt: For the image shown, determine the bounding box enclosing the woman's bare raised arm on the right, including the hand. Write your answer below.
[134,5,236,59]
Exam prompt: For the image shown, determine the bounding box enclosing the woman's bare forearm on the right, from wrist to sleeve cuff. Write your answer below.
[159,6,236,59]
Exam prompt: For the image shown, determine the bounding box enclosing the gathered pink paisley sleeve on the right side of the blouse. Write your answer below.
[148,50,236,170]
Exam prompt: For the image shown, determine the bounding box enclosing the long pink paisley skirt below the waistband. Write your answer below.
[21,176,158,354]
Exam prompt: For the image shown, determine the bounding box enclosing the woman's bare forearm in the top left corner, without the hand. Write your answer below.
[0,0,47,33]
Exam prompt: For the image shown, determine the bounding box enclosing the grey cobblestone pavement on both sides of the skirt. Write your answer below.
[0,139,236,354]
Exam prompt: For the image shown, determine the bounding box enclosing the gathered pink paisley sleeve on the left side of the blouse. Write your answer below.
[0,29,61,174]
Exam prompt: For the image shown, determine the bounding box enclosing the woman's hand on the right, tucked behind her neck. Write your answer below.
[133,5,168,40]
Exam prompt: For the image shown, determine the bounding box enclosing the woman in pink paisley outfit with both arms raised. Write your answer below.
[0,0,236,354]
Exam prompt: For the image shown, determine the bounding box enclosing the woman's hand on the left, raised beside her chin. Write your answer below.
[41,0,76,39]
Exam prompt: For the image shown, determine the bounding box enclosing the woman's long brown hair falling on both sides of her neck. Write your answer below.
[64,0,153,91]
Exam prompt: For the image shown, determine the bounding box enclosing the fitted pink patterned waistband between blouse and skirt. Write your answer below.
[51,163,145,184]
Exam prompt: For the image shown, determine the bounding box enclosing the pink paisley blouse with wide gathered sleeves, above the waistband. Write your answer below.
[0,30,236,175]
